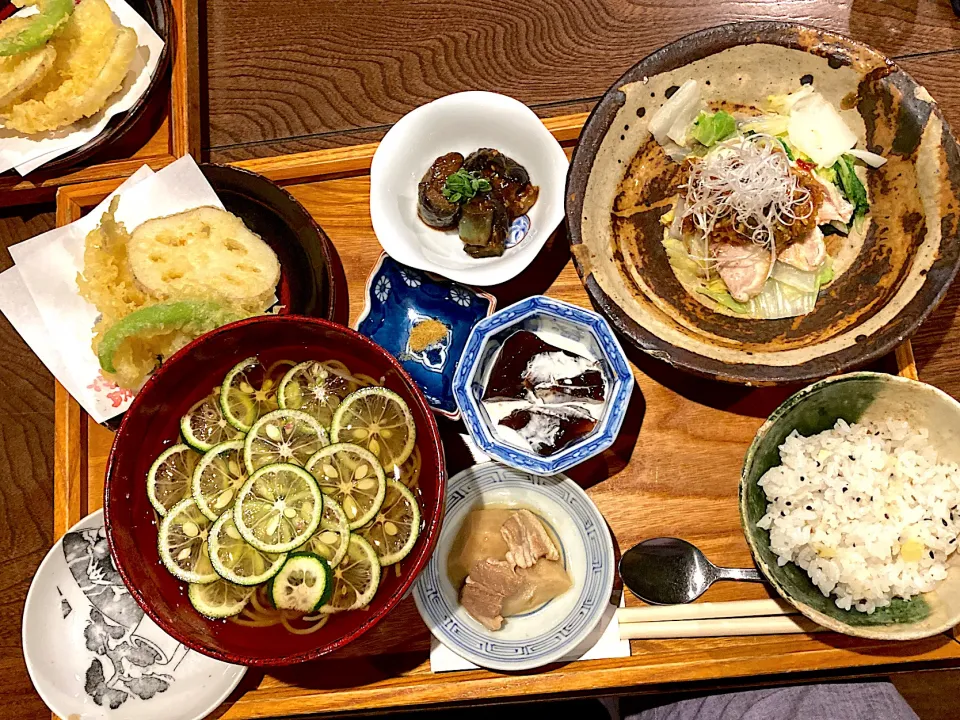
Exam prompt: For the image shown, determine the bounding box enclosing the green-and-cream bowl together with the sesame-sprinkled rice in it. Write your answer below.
[740,372,960,640]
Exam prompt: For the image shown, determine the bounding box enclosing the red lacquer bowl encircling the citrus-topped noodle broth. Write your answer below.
[103,315,446,666]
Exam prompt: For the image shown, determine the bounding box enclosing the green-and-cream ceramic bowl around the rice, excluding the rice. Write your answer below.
[740,372,960,640]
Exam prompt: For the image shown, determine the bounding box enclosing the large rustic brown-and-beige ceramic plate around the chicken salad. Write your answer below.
[566,22,960,384]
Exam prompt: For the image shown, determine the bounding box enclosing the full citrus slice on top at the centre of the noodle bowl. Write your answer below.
[233,463,323,553]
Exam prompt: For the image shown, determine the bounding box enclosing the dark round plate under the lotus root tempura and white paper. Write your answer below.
[200,164,349,324]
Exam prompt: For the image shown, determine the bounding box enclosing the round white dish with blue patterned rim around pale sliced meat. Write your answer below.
[413,462,615,671]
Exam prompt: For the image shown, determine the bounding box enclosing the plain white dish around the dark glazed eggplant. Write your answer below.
[370,91,569,286]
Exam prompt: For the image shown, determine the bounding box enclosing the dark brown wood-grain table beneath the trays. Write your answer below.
[0,0,960,718]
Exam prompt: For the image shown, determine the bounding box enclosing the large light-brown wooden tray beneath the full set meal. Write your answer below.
[54,115,960,719]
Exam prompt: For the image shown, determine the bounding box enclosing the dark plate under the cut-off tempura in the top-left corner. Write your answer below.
[0,0,176,176]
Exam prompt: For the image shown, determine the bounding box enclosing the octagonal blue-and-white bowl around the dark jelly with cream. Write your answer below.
[453,295,633,475]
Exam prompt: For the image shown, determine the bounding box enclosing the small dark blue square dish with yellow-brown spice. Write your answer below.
[356,253,497,420]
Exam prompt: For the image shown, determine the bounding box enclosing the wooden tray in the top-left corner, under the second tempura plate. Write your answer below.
[0,0,200,207]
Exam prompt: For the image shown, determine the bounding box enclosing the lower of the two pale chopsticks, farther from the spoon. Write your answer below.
[620,615,826,640]
